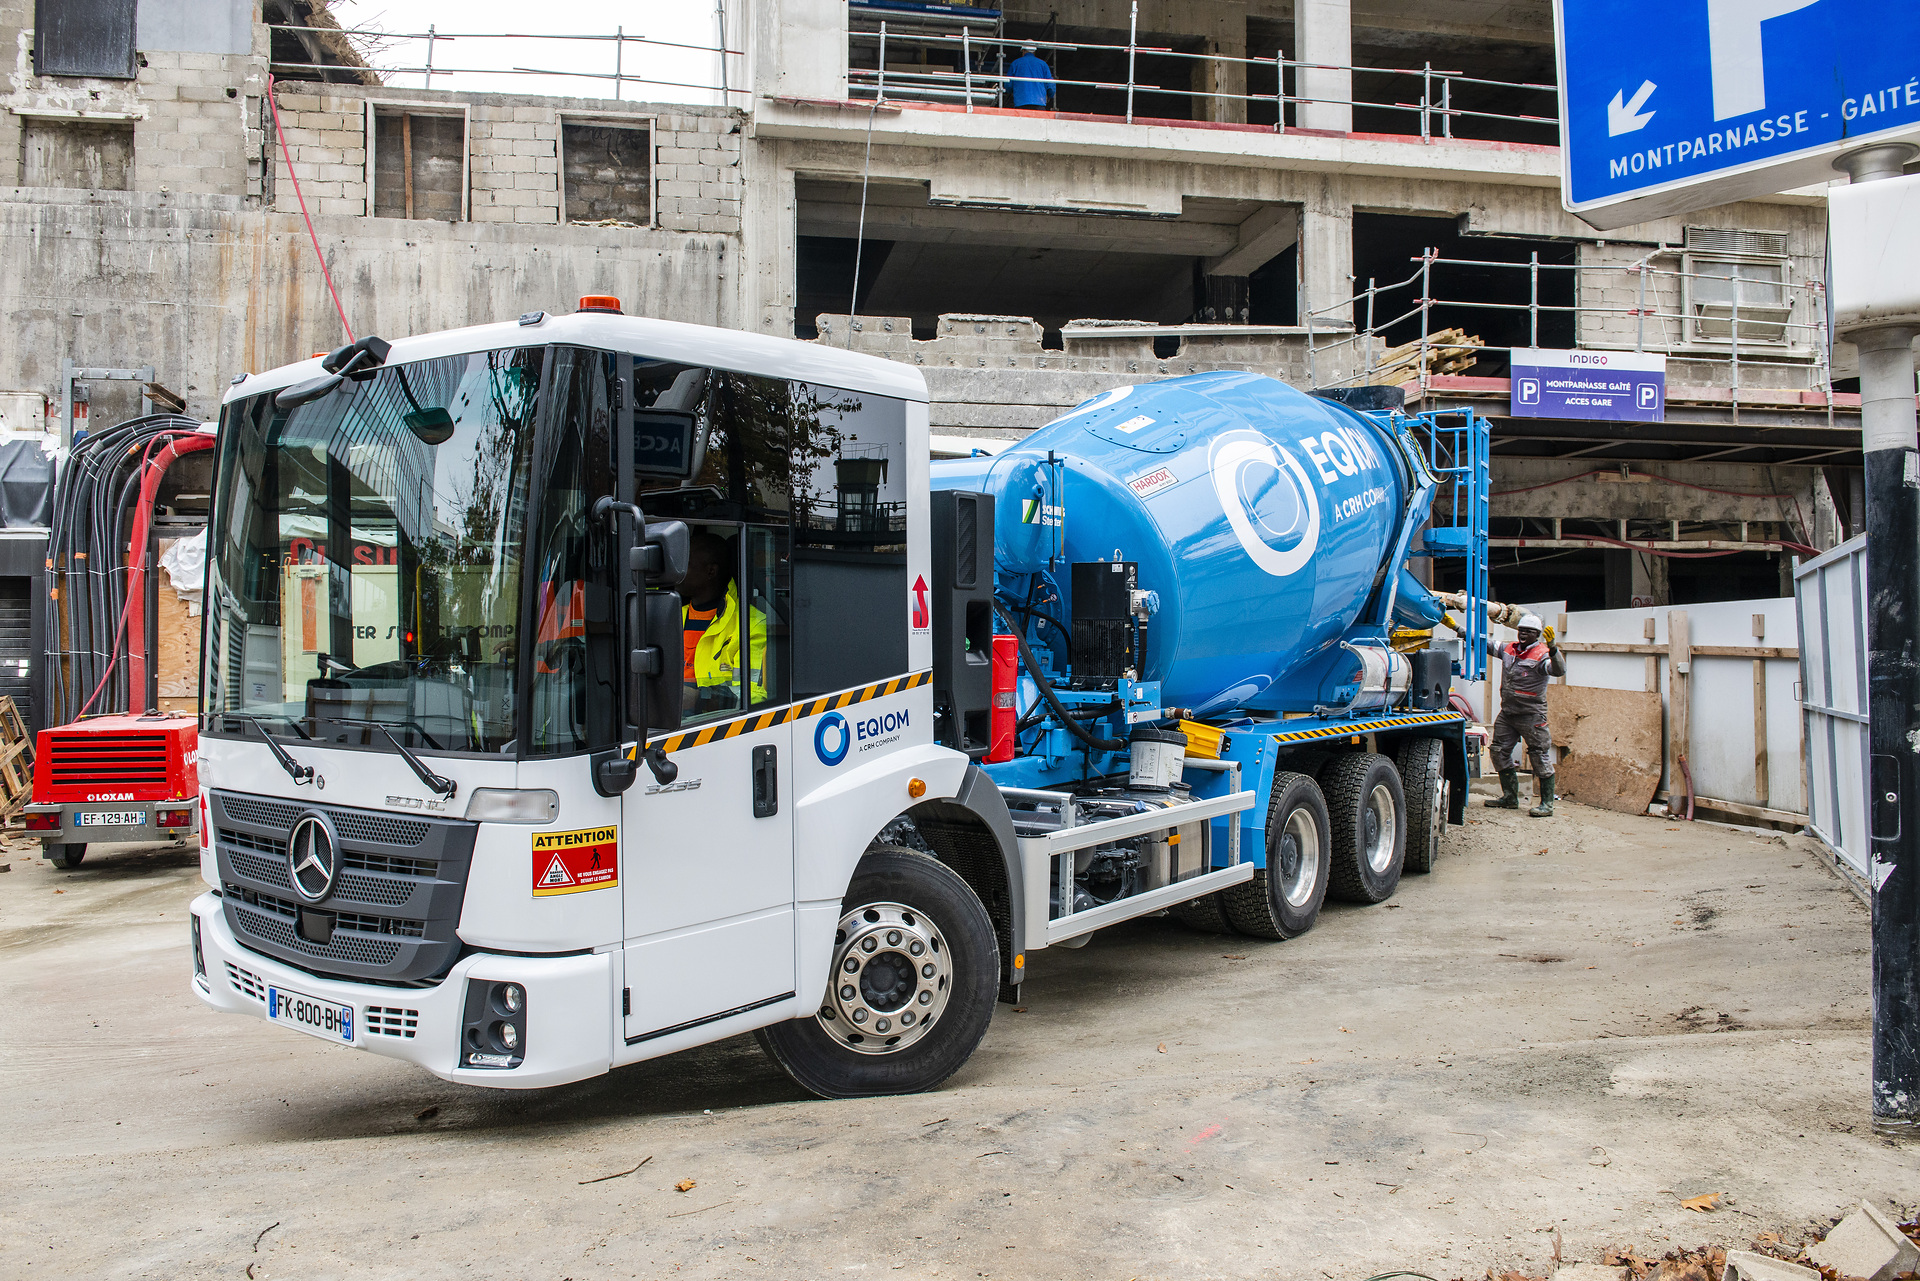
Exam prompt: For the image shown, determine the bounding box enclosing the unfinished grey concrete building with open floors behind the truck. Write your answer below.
[0,0,1889,691]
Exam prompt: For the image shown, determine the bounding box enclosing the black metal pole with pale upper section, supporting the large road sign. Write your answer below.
[1839,146,1920,1135]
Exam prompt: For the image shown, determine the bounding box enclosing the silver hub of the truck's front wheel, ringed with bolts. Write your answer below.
[816,903,952,1054]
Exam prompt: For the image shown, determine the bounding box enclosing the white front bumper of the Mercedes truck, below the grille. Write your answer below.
[192,893,616,1089]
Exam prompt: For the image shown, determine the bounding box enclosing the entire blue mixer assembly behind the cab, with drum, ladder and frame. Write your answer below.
[933,373,1488,921]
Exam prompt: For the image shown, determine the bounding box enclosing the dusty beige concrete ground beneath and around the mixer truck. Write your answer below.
[0,803,1920,1281]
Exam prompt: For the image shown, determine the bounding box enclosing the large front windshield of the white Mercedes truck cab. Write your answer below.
[205,348,545,753]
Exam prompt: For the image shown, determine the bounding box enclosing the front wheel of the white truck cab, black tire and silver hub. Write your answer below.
[755,845,1000,1099]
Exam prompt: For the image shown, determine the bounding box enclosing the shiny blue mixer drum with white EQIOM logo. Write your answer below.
[933,373,1432,714]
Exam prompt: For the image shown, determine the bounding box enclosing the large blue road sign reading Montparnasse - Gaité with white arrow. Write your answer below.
[1553,0,1920,229]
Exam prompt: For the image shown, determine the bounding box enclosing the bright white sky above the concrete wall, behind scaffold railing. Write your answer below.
[332,0,745,104]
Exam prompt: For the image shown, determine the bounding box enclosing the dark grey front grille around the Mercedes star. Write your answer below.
[209,791,478,983]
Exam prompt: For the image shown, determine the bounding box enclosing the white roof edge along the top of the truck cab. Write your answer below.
[221,311,927,403]
